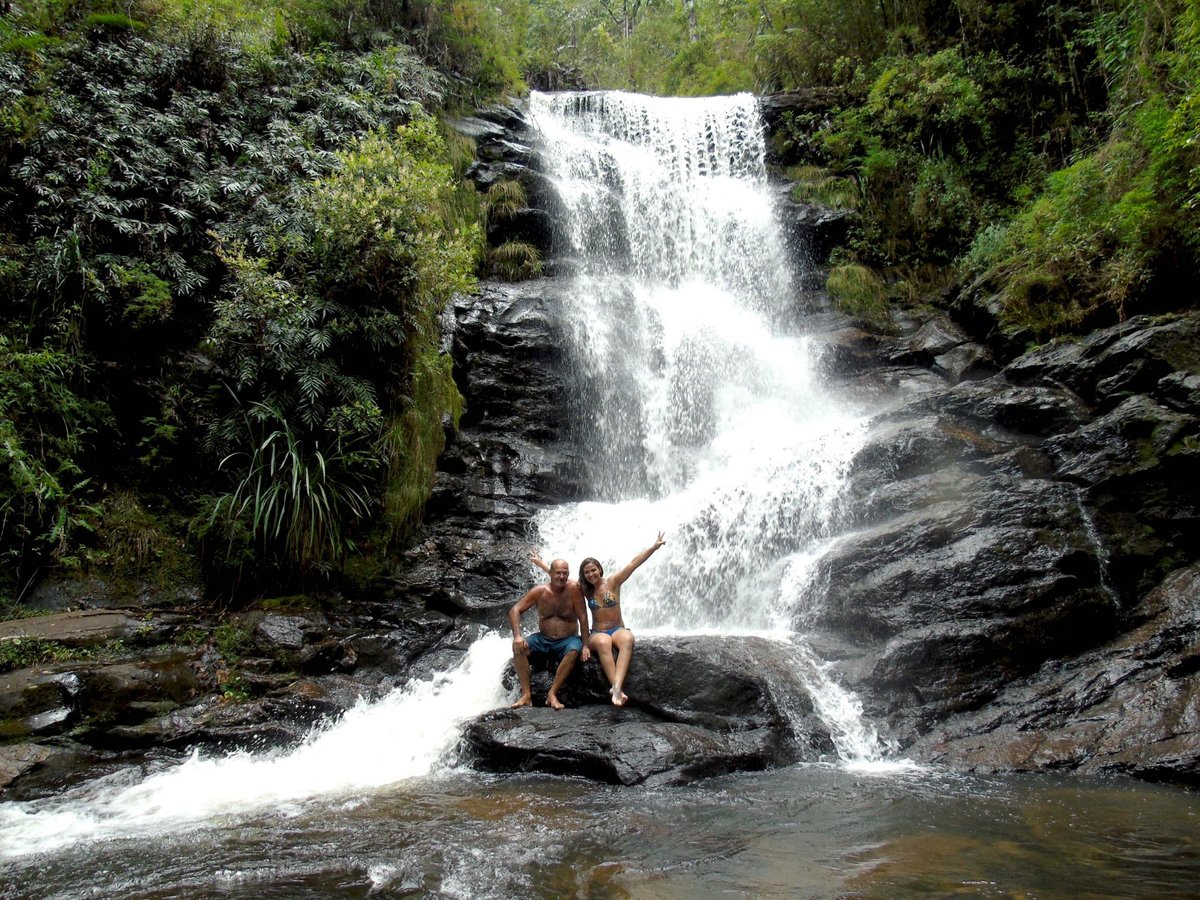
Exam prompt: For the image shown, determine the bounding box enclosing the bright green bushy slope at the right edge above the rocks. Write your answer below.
[965,4,1200,336]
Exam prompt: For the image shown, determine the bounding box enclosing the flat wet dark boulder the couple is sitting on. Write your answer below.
[463,636,833,785]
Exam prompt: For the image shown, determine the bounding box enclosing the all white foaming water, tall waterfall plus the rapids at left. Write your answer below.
[0,94,902,858]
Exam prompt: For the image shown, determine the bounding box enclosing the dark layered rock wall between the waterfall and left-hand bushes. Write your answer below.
[386,282,583,624]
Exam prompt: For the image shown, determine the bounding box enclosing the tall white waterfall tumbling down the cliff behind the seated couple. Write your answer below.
[530,92,882,760]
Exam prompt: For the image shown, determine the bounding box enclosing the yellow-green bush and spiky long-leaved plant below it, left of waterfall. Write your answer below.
[210,116,472,568]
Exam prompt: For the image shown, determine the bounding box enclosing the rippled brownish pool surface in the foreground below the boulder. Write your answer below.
[0,767,1200,898]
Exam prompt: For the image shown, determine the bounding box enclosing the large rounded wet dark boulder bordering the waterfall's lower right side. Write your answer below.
[811,478,1116,736]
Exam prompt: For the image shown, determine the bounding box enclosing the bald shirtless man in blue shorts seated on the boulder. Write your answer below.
[509,559,592,709]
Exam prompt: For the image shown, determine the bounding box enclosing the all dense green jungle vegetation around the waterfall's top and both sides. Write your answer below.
[0,0,1200,605]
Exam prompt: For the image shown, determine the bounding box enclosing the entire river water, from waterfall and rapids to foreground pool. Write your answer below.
[0,94,1200,898]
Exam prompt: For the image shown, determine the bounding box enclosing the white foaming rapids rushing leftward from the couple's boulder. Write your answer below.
[0,635,512,858]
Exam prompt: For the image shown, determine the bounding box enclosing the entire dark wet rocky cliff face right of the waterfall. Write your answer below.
[805,304,1200,780]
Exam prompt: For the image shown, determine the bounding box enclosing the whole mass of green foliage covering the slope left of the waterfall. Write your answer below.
[0,10,482,592]
